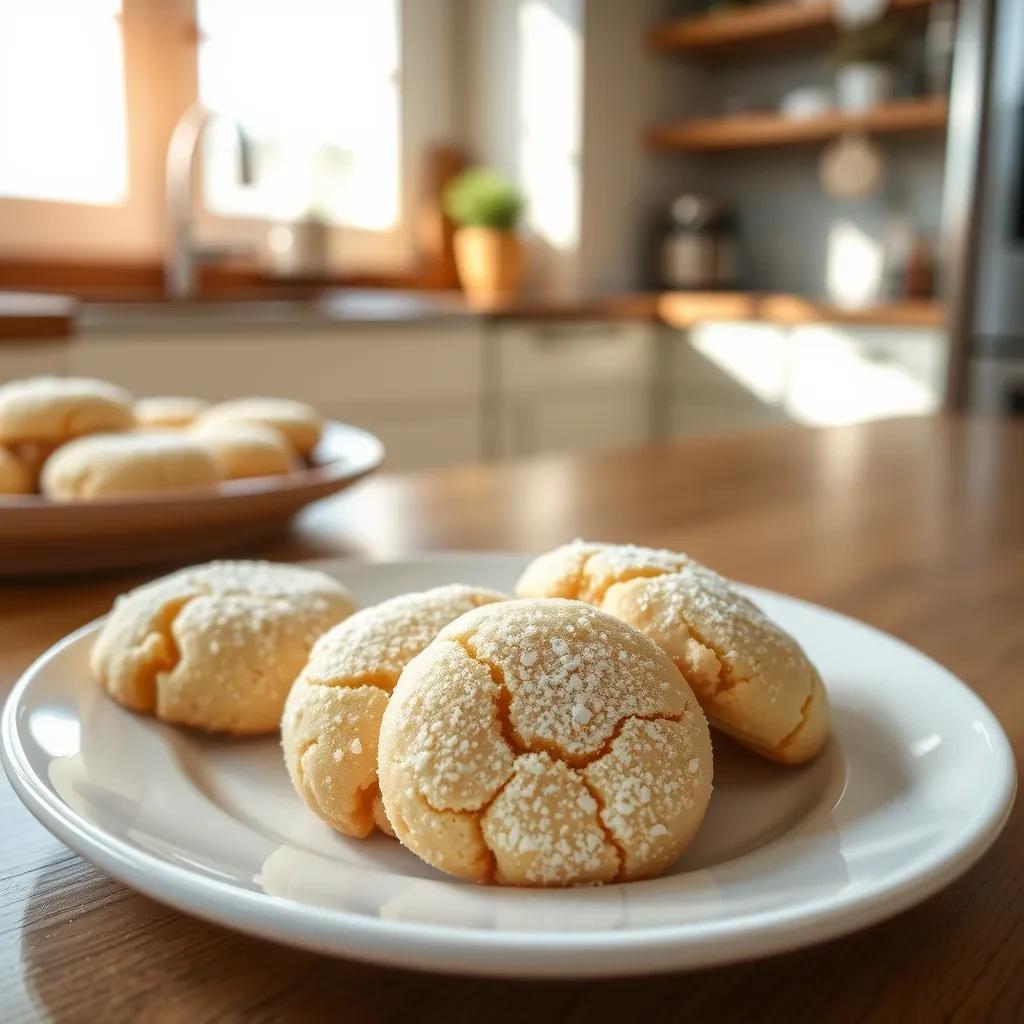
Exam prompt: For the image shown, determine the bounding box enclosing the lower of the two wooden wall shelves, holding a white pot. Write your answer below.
[647,96,948,153]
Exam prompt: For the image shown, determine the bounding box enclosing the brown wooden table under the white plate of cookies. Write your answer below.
[0,420,1024,1024]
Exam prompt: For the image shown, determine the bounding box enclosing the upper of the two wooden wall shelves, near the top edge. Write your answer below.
[647,0,936,56]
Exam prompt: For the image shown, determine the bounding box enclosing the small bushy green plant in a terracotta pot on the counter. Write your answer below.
[444,167,522,307]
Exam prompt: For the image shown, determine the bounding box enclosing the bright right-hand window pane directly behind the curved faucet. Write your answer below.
[197,0,401,231]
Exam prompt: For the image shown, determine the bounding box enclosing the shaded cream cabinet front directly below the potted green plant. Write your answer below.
[486,321,654,457]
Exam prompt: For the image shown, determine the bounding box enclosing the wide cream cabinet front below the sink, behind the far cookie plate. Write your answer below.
[69,322,483,469]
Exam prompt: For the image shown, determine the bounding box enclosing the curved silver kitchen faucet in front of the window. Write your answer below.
[164,103,254,299]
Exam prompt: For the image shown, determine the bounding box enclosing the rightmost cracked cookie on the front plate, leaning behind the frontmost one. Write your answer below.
[516,541,828,764]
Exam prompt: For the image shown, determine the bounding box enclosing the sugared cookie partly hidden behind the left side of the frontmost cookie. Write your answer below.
[281,584,508,836]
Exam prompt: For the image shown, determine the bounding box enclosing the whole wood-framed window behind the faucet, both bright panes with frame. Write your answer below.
[0,0,450,273]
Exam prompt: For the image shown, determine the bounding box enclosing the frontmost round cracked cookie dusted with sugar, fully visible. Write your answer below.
[378,599,712,886]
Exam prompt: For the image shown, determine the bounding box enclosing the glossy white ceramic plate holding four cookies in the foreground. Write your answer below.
[2,555,1016,976]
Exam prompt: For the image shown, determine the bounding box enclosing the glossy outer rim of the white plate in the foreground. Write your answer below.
[0,565,1017,978]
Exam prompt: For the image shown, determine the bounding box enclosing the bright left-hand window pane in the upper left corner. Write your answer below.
[0,0,128,205]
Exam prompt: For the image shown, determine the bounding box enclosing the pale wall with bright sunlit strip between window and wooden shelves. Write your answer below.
[453,0,702,299]
